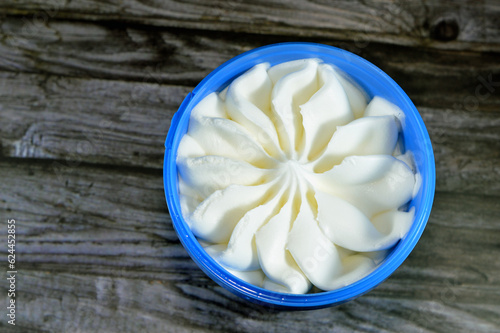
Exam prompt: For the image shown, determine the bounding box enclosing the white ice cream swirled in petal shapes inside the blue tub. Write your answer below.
[177,59,416,294]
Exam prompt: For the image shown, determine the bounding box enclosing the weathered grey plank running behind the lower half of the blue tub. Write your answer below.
[0,159,500,312]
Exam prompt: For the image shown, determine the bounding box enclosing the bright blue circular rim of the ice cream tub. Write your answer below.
[163,42,436,309]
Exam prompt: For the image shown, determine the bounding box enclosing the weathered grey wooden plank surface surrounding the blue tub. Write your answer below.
[0,0,500,332]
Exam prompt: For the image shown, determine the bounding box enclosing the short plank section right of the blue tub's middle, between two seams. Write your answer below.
[419,108,500,195]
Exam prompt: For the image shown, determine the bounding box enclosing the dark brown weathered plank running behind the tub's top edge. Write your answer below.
[0,17,500,110]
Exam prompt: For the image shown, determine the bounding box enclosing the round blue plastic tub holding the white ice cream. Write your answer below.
[163,43,436,310]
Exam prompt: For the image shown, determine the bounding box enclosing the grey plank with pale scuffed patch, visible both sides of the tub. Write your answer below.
[0,72,500,194]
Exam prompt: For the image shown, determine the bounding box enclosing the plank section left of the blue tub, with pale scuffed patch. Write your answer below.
[0,73,191,168]
